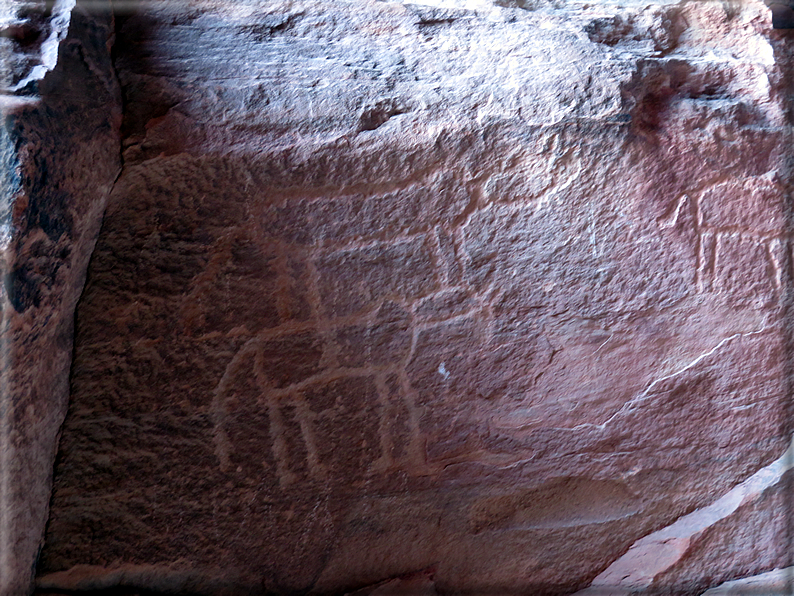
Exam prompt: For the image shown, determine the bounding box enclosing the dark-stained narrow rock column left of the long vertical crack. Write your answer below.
[0,2,121,596]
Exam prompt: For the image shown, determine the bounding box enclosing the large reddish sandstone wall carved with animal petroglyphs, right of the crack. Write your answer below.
[34,0,792,595]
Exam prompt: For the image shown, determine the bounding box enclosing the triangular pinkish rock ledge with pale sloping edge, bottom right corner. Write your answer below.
[577,436,794,596]
